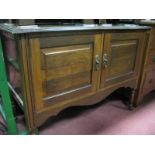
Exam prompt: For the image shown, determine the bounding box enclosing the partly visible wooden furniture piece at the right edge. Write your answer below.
[135,20,155,106]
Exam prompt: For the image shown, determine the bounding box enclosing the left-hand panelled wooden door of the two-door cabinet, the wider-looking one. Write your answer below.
[30,34,102,111]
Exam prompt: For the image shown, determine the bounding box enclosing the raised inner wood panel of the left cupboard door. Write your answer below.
[41,44,93,96]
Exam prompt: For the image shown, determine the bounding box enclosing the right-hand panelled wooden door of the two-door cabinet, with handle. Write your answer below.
[100,32,143,89]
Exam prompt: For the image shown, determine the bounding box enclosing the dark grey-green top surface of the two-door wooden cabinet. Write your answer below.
[0,23,150,34]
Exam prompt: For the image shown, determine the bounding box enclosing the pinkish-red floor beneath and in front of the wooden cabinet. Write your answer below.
[0,93,155,135]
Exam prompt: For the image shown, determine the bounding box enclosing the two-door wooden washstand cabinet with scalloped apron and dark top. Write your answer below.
[0,24,149,132]
